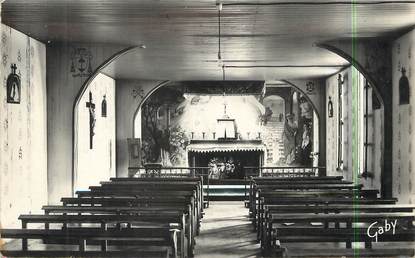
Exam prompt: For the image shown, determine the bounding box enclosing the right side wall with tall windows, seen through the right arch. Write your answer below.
[326,67,383,189]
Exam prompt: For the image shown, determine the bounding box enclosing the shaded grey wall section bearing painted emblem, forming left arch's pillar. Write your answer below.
[46,43,125,204]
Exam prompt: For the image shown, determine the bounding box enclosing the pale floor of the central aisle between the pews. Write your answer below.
[195,201,261,258]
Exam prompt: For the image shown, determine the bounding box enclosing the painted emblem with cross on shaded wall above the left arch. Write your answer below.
[70,48,92,77]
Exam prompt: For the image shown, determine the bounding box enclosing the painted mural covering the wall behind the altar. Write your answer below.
[141,84,314,166]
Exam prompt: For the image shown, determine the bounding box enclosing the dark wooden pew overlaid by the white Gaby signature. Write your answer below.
[263,212,415,256]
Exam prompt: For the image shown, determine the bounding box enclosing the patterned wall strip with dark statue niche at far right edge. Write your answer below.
[392,28,415,203]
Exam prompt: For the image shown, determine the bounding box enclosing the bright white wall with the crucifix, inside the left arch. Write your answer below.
[75,73,116,191]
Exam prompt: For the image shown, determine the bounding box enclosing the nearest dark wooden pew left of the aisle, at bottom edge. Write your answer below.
[1,227,177,257]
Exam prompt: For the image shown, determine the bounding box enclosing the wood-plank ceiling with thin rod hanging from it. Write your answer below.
[2,0,415,81]
